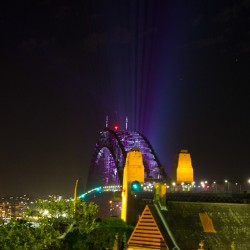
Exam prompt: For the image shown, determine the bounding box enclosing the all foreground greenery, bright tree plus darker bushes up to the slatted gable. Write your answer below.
[0,199,133,250]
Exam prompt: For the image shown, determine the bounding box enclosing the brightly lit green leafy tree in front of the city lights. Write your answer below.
[0,198,98,250]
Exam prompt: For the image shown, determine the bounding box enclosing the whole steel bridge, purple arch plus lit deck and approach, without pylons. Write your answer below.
[83,128,249,222]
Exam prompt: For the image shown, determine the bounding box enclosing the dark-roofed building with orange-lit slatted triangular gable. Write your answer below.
[127,201,250,250]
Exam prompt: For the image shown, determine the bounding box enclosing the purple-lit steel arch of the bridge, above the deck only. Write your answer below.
[86,129,168,190]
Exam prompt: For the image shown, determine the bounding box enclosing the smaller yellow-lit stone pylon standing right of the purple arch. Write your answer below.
[176,149,194,183]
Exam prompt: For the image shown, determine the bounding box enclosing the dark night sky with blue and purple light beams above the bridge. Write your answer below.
[0,0,250,196]
